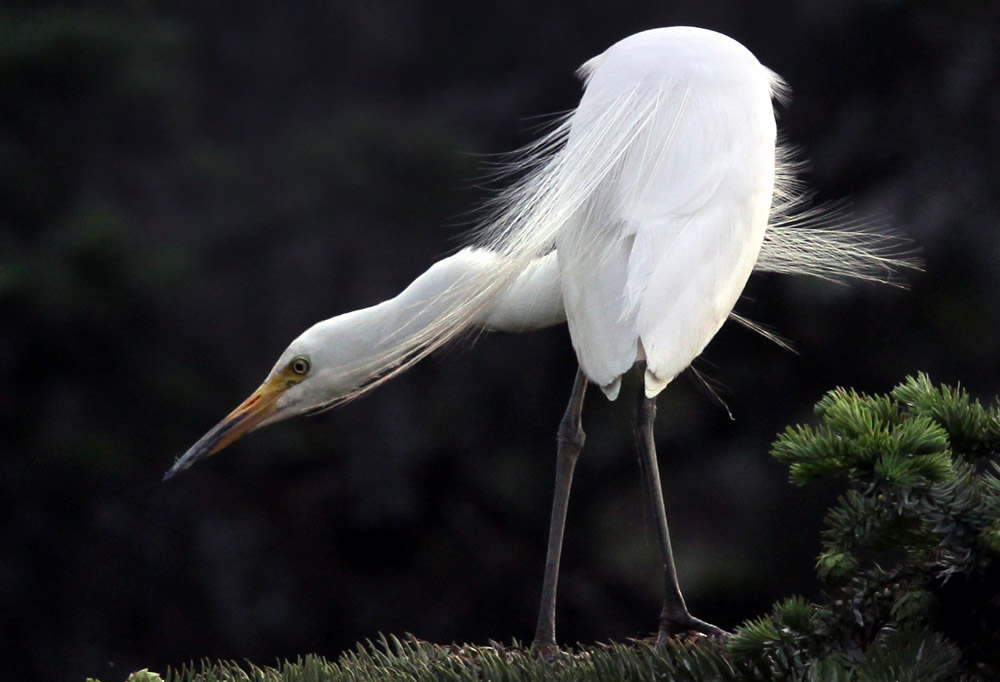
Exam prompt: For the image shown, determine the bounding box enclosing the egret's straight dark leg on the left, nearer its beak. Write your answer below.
[532,369,587,656]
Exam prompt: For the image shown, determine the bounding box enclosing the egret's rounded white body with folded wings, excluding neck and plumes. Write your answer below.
[556,28,777,398]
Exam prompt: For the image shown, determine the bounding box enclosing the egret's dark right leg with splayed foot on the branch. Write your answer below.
[635,387,726,646]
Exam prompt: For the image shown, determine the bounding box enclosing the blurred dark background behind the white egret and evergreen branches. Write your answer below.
[0,0,1000,680]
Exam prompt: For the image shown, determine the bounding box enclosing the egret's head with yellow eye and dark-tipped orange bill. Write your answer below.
[163,323,340,480]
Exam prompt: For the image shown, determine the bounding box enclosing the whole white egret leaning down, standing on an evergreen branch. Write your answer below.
[166,27,905,649]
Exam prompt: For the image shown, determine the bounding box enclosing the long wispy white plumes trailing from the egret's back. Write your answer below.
[324,39,916,407]
